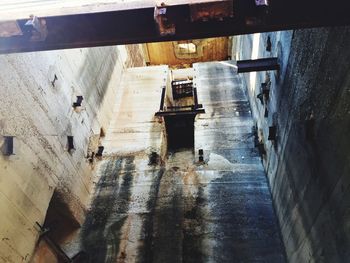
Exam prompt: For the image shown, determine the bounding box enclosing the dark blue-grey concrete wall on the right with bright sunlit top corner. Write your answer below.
[237,28,350,262]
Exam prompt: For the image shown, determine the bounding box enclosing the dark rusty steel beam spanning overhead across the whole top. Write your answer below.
[0,0,350,54]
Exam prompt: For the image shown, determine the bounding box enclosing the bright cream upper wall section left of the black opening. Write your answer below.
[103,66,169,155]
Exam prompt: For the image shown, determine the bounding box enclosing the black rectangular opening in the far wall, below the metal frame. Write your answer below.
[164,114,196,151]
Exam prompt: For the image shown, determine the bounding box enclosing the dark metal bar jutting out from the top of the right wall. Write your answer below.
[237,58,280,73]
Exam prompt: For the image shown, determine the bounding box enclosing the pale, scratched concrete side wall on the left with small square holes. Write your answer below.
[0,44,144,263]
